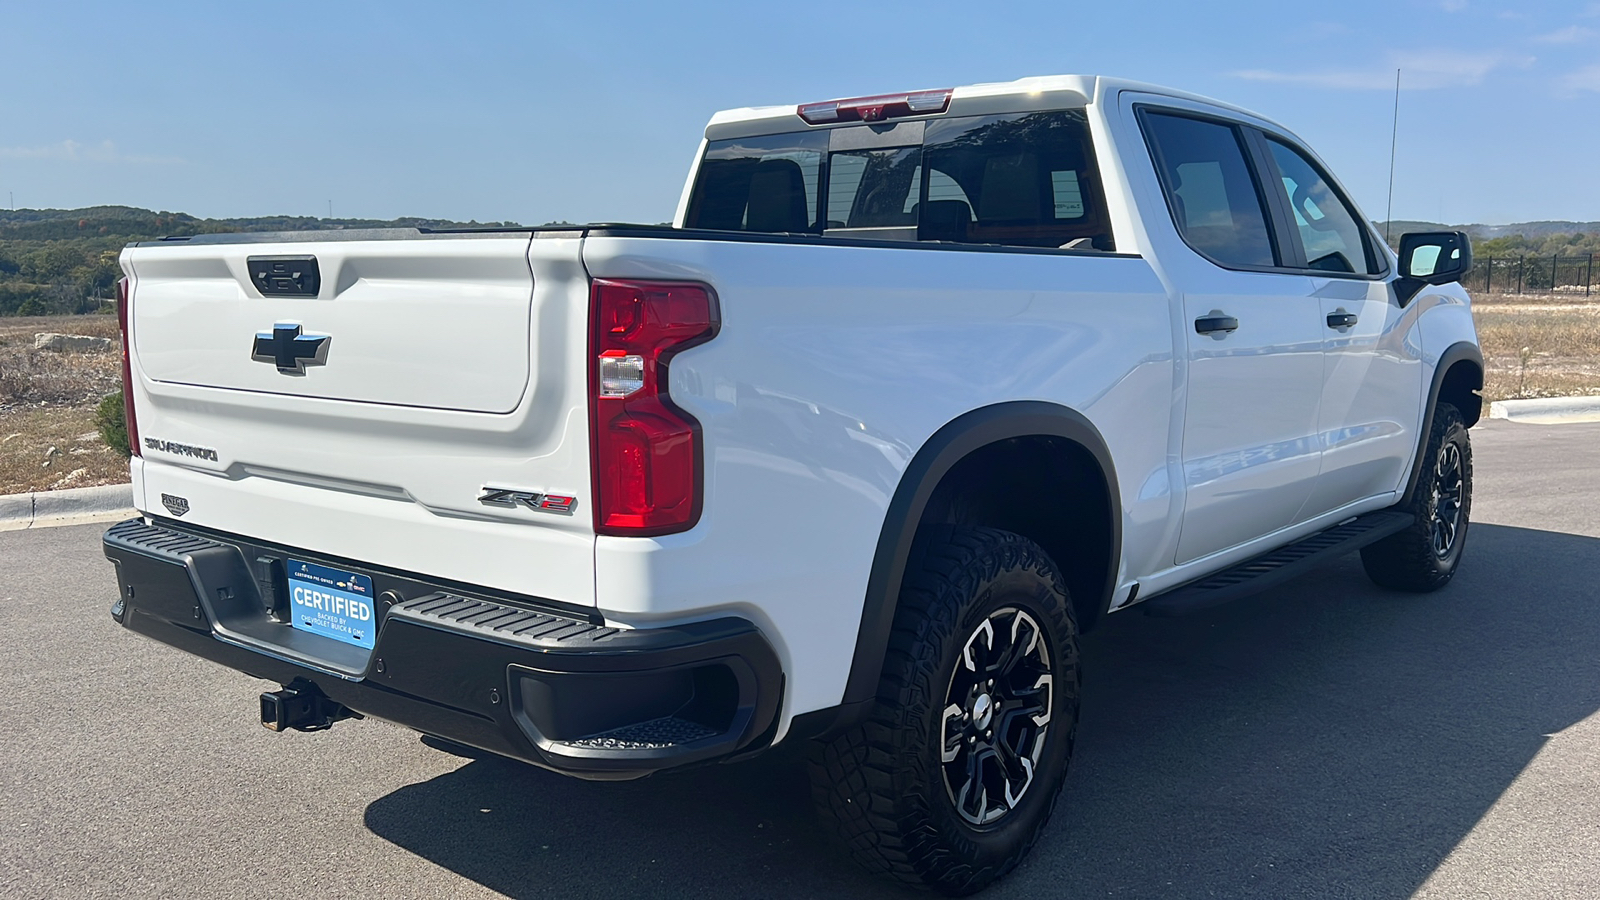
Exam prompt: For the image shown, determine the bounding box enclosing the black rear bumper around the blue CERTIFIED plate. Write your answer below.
[104,519,782,780]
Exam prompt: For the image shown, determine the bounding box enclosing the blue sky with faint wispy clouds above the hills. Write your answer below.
[0,0,1600,224]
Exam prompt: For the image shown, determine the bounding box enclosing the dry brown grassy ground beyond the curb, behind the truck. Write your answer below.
[0,293,1600,493]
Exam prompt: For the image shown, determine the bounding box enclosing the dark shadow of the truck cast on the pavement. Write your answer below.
[366,524,1600,897]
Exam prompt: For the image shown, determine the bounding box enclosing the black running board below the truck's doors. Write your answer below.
[1139,511,1416,618]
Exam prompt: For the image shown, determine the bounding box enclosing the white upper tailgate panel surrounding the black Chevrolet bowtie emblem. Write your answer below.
[134,235,533,413]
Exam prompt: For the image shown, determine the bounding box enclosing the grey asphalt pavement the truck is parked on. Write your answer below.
[0,421,1600,900]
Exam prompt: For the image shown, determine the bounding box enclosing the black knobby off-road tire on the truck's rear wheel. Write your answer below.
[810,525,1078,895]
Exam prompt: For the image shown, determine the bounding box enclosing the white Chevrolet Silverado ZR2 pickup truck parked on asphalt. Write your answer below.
[106,77,1483,894]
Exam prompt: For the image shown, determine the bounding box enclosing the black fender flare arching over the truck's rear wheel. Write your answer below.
[838,400,1122,714]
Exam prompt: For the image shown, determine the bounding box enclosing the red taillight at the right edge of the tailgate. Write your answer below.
[589,279,720,536]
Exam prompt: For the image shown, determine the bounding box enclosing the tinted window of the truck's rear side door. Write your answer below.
[1144,112,1278,266]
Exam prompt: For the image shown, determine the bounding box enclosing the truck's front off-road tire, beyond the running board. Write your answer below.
[1362,404,1472,594]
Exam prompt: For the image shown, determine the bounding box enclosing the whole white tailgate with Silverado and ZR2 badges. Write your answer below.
[123,232,594,605]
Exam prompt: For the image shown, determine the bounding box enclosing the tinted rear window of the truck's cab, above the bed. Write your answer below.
[685,110,1115,250]
